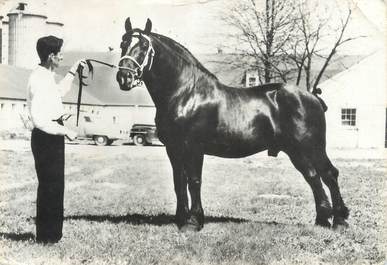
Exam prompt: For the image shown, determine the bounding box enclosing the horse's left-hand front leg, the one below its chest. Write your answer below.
[166,145,189,229]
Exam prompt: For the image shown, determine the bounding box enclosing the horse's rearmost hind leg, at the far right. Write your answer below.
[316,152,349,228]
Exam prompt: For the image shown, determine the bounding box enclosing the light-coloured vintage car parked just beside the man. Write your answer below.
[63,114,129,145]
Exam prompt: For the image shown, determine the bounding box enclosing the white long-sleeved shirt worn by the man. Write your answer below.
[27,65,74,135]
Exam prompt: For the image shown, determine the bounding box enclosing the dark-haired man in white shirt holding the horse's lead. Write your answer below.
[27,36,86,244]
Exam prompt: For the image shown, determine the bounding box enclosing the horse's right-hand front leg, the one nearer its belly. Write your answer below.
[182,144,204,231]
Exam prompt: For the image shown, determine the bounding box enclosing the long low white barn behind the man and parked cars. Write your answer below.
[0,64,155,131]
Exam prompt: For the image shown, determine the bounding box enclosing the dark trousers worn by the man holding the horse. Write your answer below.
[31,125,65,243]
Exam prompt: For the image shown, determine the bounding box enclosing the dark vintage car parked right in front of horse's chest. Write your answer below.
[129,124,161,146]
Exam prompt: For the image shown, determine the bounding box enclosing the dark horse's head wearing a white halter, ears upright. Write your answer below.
[116,18,155,91]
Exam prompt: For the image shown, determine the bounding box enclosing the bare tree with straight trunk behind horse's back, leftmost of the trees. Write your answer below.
[223,0,296,83]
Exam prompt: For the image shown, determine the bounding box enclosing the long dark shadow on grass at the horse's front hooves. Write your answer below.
[65,214,248,226]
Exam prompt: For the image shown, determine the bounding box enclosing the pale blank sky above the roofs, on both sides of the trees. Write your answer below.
[0,0,385,54]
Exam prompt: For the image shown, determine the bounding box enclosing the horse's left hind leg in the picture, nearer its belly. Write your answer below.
[288,152,332,227]
